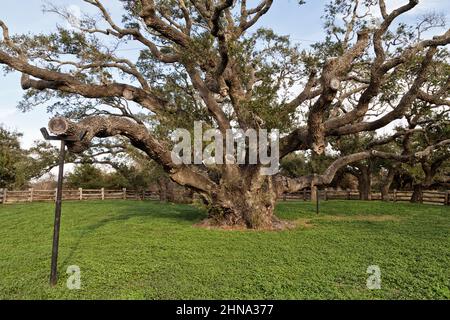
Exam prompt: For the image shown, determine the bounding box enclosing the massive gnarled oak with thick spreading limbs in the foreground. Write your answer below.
[0,0,450,228]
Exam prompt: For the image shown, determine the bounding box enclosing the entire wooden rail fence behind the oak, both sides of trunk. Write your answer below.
[0,188,450,205]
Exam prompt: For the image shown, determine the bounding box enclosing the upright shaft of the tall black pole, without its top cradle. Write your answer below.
[50,140,66,286]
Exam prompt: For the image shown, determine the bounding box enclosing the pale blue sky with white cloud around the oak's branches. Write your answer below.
[0,0,450,147]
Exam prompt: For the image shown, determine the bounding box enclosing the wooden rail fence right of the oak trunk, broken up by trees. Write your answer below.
[282,189,450,205]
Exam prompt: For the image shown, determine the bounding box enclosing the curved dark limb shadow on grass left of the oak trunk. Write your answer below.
[61,202,207,265]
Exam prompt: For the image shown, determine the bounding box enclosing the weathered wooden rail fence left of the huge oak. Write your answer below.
[0,188,159,203]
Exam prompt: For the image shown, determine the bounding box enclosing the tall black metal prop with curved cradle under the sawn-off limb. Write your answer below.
[41,128,86,286]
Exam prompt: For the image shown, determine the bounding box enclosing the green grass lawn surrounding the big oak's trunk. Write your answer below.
[0,201,450,299]
